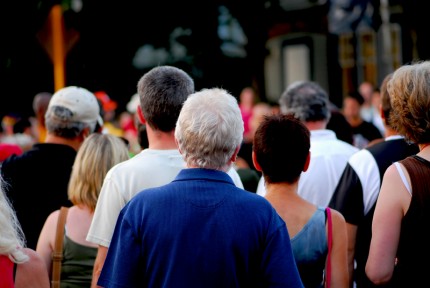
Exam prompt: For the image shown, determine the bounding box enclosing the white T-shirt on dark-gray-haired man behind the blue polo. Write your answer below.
[86,149,243,247]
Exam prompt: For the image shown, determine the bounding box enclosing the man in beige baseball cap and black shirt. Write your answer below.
[1,86,102,249]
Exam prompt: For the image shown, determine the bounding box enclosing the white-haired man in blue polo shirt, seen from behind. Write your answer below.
[98,88,303,287]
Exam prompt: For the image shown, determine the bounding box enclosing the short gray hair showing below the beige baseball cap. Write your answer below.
[45,106,97,139]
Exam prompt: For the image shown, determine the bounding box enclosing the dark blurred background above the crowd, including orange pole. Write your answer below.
[0,0,430,116]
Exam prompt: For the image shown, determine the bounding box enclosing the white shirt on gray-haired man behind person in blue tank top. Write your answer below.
[257,129,359,207]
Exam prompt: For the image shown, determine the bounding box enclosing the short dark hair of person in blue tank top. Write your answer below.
[253,114,311,183]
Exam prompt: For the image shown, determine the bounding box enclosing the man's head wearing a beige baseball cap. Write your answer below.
[45,86,103,139]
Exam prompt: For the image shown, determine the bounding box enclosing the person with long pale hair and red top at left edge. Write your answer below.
[0,173,49,288]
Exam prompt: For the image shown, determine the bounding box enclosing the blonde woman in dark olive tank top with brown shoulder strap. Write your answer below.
[36,133,129,287]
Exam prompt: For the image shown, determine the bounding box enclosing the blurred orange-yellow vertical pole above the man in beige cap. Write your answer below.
[51,4,65,91]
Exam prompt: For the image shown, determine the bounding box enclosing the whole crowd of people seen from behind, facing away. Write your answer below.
[0,61,430,288]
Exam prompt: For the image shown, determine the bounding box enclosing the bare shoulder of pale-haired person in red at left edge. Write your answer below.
[15,248,50,288]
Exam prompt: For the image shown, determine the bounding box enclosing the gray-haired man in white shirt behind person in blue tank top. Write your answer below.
[257,81,358,207]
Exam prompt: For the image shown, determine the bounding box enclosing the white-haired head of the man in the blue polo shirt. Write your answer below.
[175,88,244,171]
